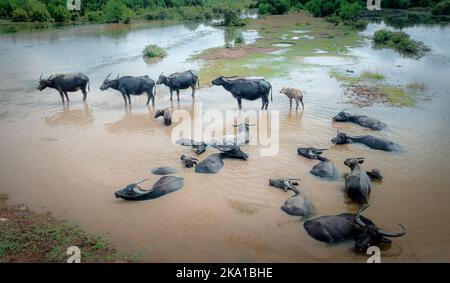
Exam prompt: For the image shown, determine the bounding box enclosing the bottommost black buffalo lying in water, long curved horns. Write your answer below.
[303,206,406,252]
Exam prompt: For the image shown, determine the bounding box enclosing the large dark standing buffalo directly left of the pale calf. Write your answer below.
[211,76,273,109]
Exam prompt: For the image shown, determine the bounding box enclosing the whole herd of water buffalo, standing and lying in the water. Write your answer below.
[38,70,406,255]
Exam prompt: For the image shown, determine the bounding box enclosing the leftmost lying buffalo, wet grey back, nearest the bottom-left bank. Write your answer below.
[115,176,184,201]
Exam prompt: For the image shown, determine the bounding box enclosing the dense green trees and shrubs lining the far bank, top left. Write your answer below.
[0,0,255,22]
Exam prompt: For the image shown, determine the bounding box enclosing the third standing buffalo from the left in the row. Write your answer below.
[156,70,200,100]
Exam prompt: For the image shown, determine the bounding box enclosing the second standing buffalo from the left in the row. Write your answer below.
[100,74,156,106]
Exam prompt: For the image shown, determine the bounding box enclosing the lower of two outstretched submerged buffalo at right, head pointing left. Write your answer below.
[331,131,401,151]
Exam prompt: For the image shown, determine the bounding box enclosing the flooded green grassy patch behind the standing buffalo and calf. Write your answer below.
[196,12,361,85]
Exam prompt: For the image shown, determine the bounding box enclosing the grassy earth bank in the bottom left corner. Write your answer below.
[0,194,138,263]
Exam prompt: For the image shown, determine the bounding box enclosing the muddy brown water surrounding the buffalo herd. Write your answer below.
[0,21,450,262]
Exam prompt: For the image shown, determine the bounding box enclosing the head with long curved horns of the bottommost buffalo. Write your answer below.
[352,205,406,252]
